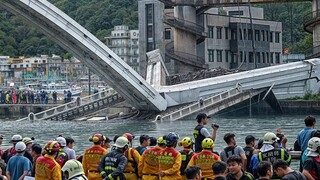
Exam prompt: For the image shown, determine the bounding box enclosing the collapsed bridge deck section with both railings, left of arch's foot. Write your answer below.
[17,90,124,121]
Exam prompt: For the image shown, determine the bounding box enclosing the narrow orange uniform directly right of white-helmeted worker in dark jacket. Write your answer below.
[124,148,140,180]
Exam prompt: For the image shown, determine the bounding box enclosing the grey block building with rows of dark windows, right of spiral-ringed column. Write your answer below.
[204,7,282,70]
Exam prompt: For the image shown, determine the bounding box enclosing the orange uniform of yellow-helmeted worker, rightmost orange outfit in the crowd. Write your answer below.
[188,150,221,179]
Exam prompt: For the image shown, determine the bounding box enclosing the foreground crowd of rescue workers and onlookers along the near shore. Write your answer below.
[0,113,320,180]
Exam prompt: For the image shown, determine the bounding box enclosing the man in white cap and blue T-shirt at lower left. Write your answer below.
[6,142,32,180]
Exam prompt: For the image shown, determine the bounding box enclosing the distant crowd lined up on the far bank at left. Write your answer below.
[0,89,72,104]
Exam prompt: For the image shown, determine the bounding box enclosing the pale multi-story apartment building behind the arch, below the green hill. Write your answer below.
[106,25,140,73]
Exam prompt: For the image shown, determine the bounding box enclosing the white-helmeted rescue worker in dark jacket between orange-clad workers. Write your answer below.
[98,136,129,180]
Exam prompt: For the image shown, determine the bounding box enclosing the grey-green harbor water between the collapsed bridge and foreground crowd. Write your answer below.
[0,115,310,169]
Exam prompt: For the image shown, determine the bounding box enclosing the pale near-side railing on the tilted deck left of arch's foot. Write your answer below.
[17,90,120,121]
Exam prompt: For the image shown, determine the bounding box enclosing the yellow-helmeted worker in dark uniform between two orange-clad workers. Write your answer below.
[179,137,194,180]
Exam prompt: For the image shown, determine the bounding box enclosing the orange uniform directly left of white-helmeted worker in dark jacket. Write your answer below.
[82,144,108,180]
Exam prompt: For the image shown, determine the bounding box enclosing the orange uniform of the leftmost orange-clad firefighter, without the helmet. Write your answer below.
[35,154,62,180]
